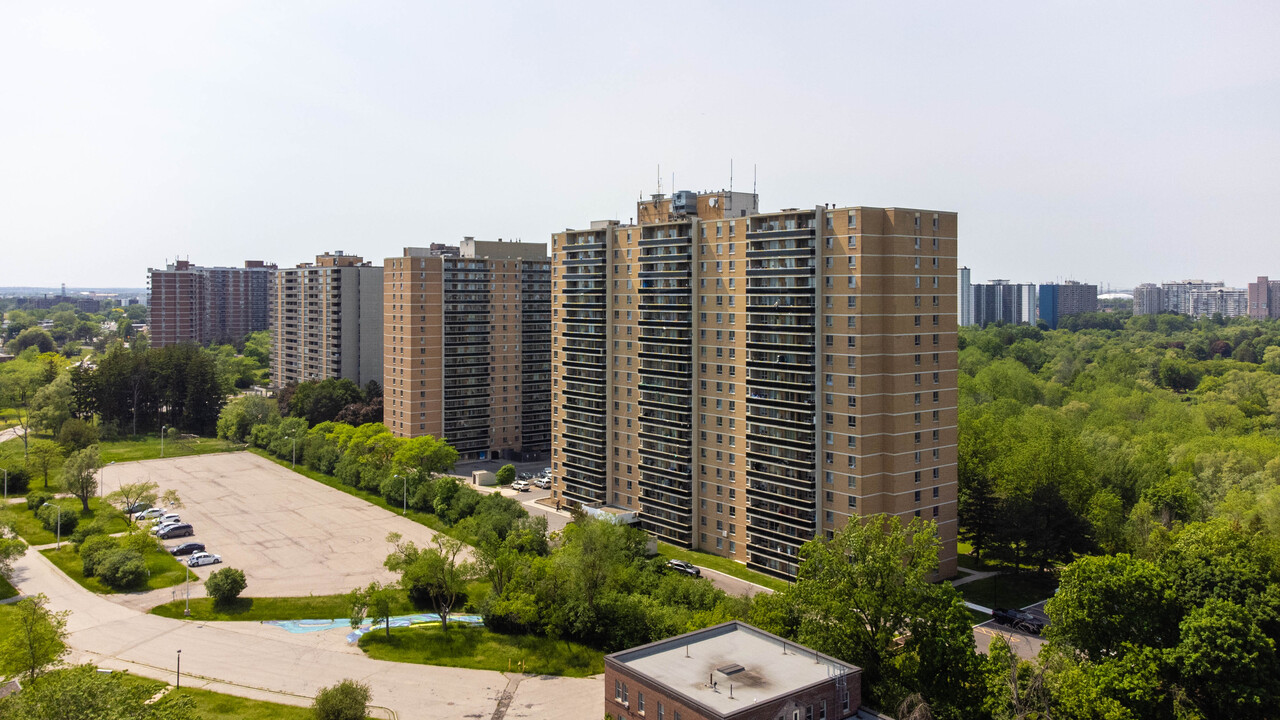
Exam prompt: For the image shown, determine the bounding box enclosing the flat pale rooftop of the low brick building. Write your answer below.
[609,620,861,715]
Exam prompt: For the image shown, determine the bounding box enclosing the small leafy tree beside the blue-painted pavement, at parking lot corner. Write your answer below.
[384,533,476,633]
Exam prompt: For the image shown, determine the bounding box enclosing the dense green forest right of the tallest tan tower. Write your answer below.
[959,315,1280,717]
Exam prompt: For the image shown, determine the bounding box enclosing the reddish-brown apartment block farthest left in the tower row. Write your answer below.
[147,260,275,347]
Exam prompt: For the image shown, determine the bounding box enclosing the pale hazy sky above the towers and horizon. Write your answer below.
[0,0,1280,287]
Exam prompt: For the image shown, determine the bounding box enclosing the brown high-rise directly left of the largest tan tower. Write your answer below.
[383,237,552,460]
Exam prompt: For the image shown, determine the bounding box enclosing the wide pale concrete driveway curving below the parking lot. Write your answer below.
[10,552,604,720]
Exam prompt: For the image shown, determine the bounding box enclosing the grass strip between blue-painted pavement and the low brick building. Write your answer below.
[360,625,604,678]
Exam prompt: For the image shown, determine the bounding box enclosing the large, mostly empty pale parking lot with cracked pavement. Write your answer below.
[105,452,450,597]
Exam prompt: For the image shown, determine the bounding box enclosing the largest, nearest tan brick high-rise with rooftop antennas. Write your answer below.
[552,192,957,578]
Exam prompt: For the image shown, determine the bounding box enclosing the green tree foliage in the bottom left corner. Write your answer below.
[0,665,200,720]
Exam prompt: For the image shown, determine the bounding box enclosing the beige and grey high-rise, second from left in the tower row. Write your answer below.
[269,251,383,387]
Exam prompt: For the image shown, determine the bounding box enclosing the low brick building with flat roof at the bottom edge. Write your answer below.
[604,620,865,720]
